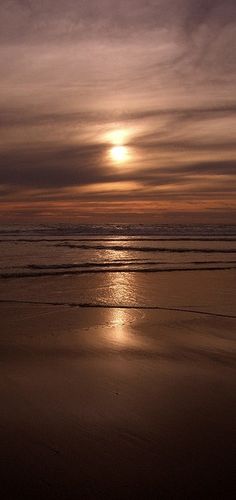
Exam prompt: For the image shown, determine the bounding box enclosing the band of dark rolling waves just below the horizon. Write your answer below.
[0,224,236,279]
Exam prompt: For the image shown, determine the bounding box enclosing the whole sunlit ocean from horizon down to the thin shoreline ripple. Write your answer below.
[0,224,236,315]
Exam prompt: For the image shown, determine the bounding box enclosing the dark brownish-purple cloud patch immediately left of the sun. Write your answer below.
[0,145,108,188]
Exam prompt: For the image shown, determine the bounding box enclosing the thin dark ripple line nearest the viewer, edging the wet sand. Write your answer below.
[0,299,236,319]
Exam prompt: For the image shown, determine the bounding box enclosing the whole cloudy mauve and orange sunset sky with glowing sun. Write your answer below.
[0,0,236,223]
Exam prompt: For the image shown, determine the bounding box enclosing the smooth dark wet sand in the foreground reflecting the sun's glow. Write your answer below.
[0,288,236,500]
